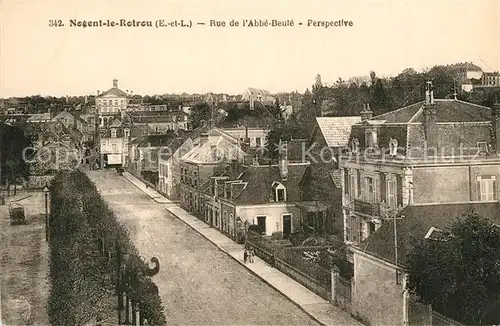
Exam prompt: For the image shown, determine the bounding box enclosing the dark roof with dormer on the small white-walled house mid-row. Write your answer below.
[234,163,309,205]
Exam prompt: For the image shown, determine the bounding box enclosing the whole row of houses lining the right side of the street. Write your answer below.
[129,83,500,325]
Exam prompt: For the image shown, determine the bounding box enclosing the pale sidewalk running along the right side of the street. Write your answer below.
[123,172,363,325]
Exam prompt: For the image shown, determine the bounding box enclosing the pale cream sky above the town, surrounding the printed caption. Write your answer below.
[0,0,500,98]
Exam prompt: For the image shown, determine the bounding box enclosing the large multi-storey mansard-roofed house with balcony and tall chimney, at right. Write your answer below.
[341,86,500,243]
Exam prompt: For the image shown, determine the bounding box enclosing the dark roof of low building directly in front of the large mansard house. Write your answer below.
[358,202,500,266]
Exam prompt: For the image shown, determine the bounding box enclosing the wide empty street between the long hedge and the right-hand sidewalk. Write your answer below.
[89,171,316,325]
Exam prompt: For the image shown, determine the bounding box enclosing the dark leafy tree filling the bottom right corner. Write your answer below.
[407,214,500,325]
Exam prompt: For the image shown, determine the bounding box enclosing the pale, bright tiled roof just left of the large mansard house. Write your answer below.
[316,117,361,147]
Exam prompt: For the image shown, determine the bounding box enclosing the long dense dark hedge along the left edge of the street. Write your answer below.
[48,171,166,325]
